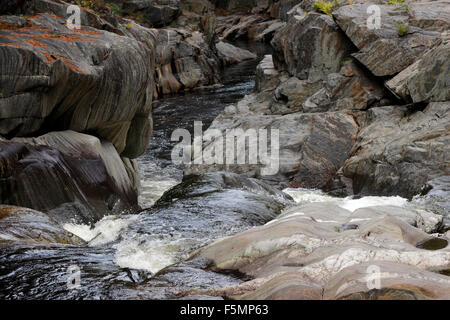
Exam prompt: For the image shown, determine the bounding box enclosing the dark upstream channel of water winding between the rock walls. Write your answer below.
[138,42,270,208]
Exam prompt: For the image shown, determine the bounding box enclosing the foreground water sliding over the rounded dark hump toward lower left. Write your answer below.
[0,173,292,299]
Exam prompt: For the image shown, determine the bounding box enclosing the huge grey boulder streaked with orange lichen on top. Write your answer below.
[0,5,154,158]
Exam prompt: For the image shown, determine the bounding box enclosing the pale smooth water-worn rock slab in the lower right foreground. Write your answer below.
[191,199,450,299]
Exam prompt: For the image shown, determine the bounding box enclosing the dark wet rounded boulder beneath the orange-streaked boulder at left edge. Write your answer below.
[0,131,138,223]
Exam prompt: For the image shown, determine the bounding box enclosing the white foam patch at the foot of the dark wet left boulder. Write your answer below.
[63,215,138,246]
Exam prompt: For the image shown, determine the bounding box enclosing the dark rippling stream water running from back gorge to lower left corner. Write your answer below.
[0,41,274,299]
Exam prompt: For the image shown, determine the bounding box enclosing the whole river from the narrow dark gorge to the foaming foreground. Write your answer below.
[0,43,274,299]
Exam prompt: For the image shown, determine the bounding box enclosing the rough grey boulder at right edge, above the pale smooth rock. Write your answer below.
[343,102,450,197]
